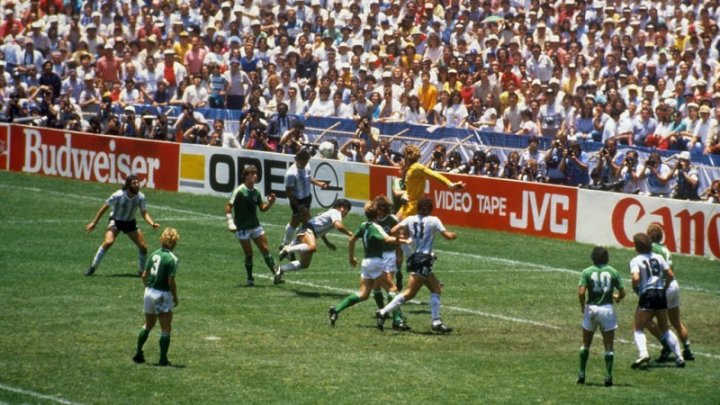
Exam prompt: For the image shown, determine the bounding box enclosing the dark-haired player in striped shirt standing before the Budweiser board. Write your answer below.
[85,174,160,276]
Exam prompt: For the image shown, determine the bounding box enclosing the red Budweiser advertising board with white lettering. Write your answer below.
[8,125,180,191]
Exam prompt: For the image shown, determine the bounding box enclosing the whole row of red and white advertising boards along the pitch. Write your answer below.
[0,125,720,258]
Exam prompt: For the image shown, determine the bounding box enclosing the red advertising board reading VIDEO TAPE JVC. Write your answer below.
[370,166,577,240]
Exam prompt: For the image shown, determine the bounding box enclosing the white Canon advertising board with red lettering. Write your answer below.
[577,190,720,258]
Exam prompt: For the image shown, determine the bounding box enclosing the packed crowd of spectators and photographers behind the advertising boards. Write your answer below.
[0,0,720,199]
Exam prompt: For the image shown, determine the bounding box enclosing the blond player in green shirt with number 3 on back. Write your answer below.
[133,228,180,366]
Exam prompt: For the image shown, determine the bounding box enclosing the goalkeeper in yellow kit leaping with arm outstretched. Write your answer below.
[397,145,465,220]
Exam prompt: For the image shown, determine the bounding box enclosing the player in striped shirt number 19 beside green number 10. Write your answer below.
[630,233,685,368]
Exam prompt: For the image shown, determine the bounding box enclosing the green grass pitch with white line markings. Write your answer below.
[0,172,720,404]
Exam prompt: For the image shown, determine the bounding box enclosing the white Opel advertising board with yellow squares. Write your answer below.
[179,144,370,212]
